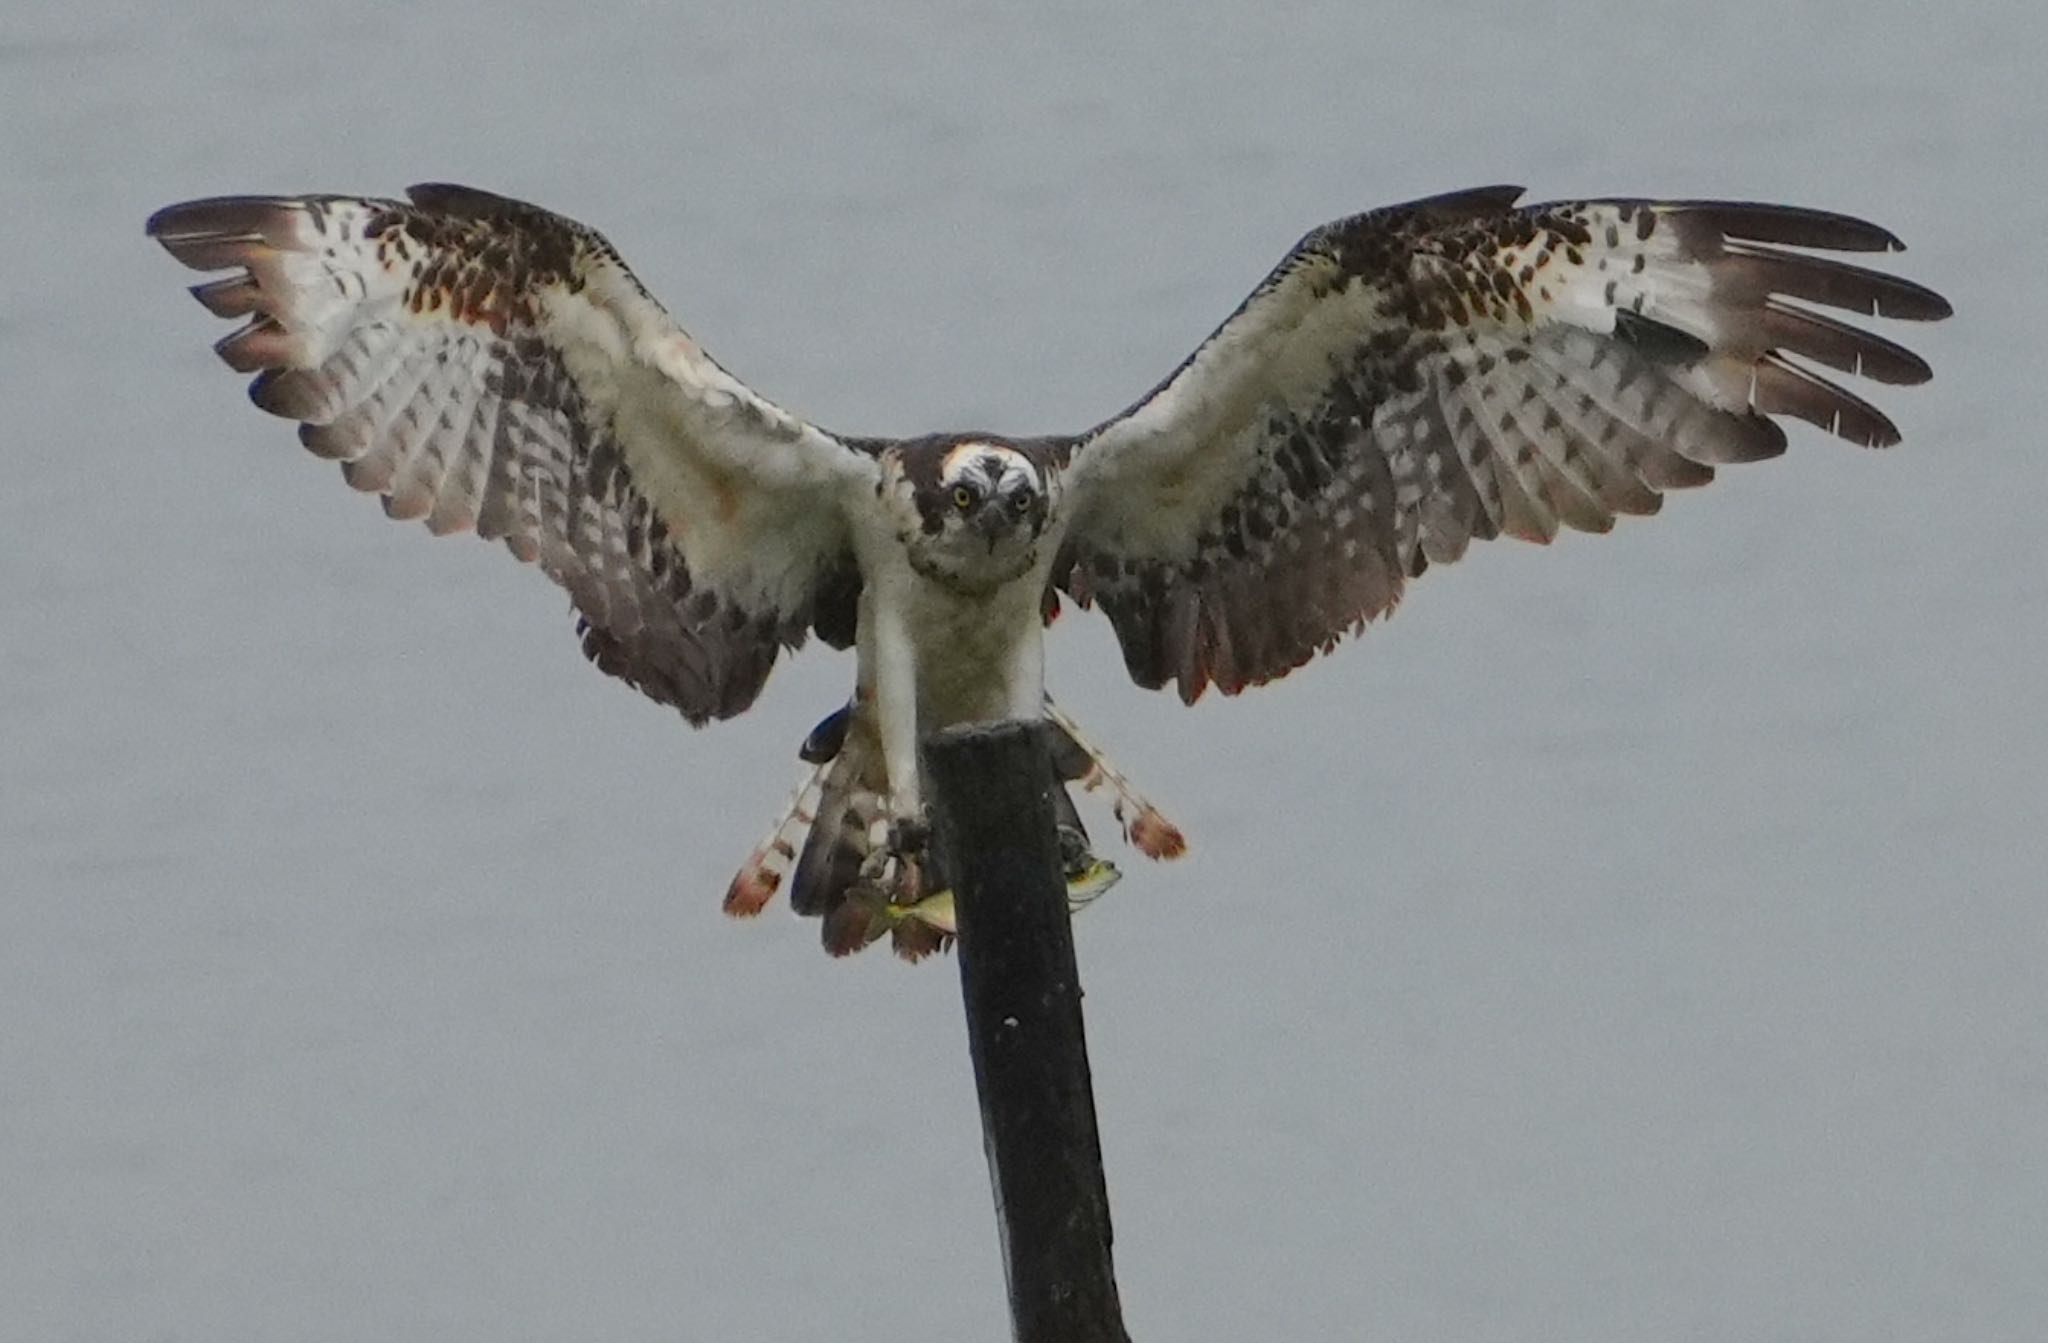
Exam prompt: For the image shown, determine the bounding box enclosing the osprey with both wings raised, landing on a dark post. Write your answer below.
[147,184,1950,954]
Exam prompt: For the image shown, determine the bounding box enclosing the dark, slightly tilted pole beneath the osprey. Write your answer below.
[924,723,1130,1343]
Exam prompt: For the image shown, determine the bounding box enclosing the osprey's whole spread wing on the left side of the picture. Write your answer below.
[150,186,874,723]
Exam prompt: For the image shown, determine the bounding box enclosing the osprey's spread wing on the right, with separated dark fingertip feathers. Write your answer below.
[1057,186,1950,700]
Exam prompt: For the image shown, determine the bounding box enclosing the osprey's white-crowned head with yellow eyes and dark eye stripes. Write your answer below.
[901,438,1053,590]
